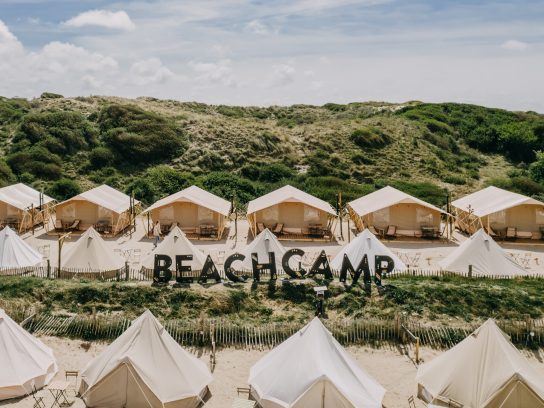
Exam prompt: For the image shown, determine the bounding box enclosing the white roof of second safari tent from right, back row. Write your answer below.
[348,186,446,217]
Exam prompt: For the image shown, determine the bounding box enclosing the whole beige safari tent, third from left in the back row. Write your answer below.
[142,186,231,239]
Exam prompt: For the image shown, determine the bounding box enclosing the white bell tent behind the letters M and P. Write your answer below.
[331,228,406,272]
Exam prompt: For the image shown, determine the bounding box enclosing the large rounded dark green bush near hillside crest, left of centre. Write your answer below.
[98,105,186,165]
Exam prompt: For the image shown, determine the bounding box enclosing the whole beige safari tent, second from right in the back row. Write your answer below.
[347,186,448,238]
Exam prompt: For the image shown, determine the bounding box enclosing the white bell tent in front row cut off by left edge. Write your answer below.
[0,309,58,400]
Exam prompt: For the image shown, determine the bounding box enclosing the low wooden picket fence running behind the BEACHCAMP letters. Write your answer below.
[0,264,544,282]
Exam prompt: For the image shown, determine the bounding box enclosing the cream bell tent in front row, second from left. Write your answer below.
[79,310,212,408]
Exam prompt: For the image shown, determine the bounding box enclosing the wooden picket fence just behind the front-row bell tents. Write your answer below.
[15,314,544,349]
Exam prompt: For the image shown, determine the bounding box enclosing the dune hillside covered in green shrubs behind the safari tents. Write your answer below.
[0,94,544,205]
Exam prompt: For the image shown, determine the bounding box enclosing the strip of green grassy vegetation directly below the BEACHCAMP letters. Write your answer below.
[0,277,544,323]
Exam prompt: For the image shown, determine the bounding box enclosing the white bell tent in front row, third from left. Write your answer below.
[248,317,385,408]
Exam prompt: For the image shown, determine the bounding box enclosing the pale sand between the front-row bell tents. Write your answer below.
[0,337,544,408]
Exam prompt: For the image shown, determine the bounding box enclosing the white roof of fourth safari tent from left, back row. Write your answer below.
[247,185,336,215]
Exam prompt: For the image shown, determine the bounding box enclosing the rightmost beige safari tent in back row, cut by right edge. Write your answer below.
[451,186,544,240]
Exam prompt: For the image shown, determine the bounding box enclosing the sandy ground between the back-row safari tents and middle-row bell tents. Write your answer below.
[19,217,544,273]
